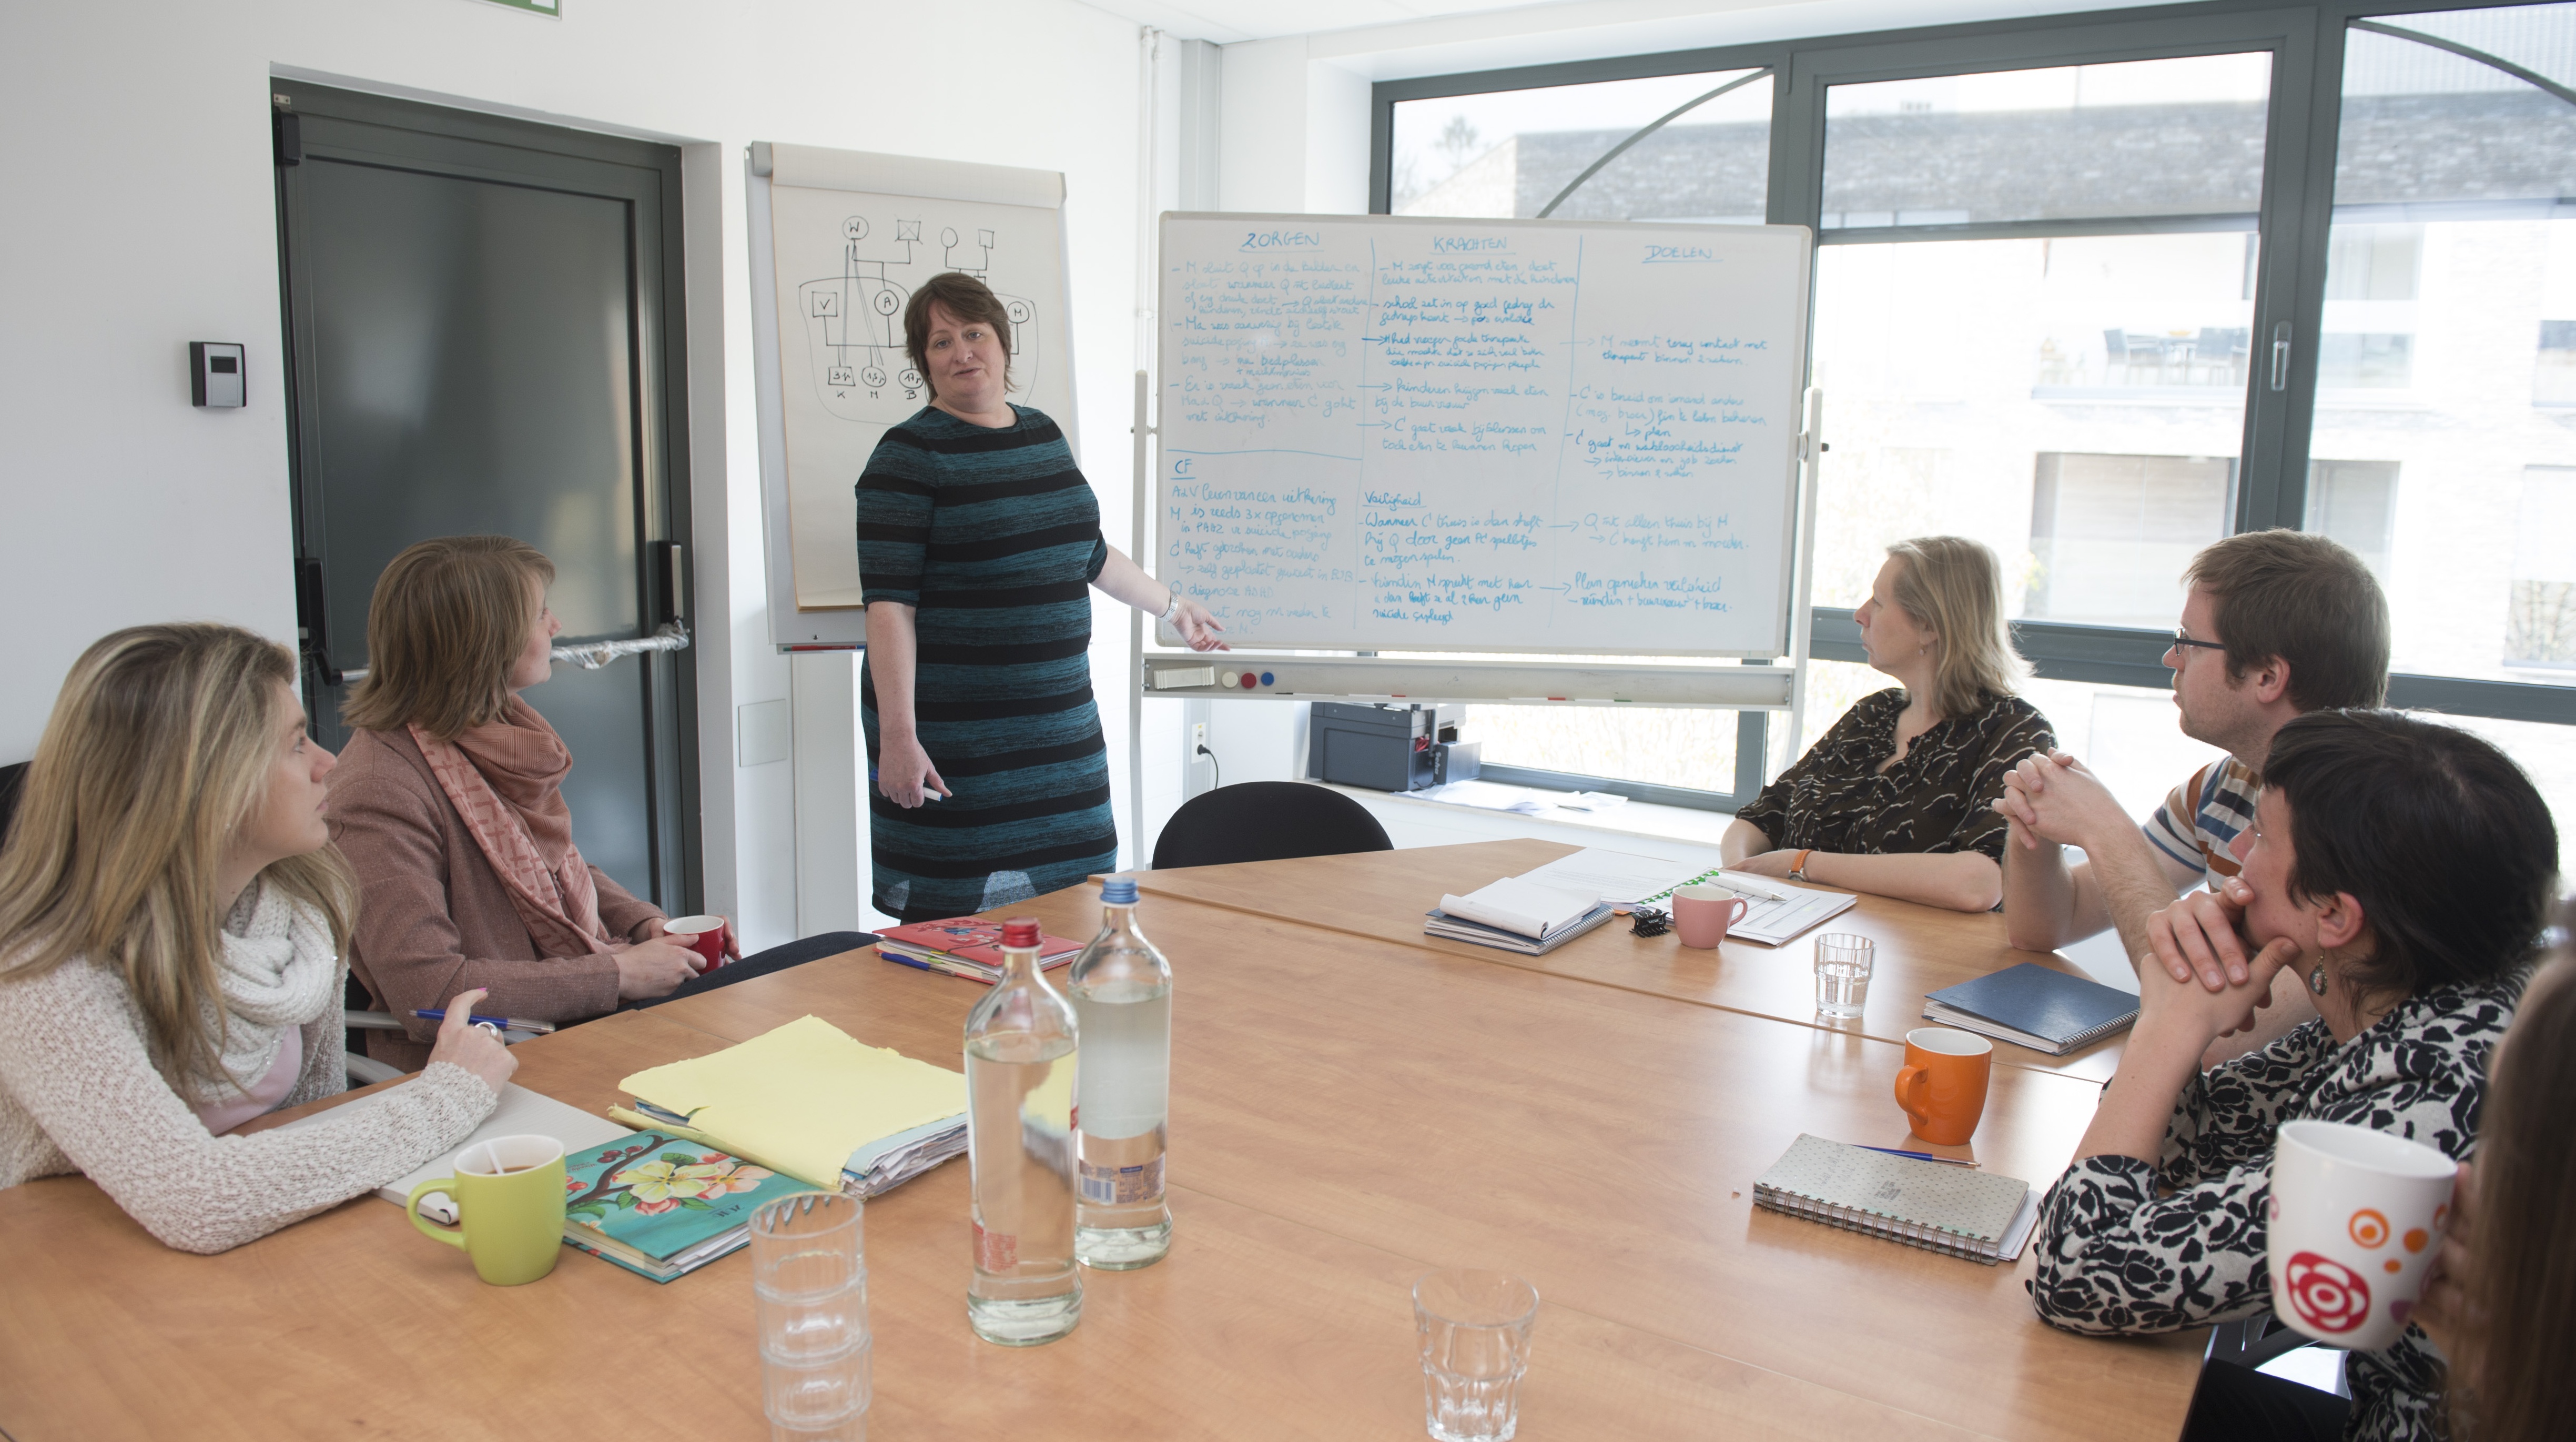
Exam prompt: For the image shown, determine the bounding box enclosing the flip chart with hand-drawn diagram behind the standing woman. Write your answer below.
[749,144,1079,647]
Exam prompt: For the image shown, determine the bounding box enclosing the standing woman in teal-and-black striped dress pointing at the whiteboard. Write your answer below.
[858,273,1224,922]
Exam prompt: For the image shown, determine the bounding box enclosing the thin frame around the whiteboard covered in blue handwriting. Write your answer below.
[1139,211,1816,664]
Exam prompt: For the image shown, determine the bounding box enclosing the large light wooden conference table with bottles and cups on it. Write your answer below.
[0,842,2197,1442]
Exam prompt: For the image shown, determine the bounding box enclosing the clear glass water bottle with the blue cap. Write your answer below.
[1064,875,1172,1272]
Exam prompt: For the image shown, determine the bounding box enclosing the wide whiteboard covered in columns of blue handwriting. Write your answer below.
[1154,214,1813,657]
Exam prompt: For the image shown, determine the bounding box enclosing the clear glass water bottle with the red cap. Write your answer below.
[966,919,1082,1347]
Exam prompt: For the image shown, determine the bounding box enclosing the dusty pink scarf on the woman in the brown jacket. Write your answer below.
[412,695,611,955]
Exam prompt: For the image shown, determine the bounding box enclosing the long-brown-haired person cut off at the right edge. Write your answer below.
[2413,906,2576,1442]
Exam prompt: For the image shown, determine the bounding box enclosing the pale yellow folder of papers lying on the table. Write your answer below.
[608,1017,966,1197]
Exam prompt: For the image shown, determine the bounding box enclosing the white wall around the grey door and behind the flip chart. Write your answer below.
[0,0,1139,942]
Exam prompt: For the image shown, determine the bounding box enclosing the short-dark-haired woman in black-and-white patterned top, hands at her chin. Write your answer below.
[2030,711,2558,1442]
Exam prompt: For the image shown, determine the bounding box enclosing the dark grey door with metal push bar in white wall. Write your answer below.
[273,83,701,912]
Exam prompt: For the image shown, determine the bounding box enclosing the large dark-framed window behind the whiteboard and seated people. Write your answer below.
[1373,0,2576,809]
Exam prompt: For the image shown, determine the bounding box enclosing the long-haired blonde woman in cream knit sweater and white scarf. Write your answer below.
[0,626,518,1252]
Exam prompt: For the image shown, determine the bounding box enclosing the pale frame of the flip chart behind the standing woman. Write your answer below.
[742,142,1082,651]
